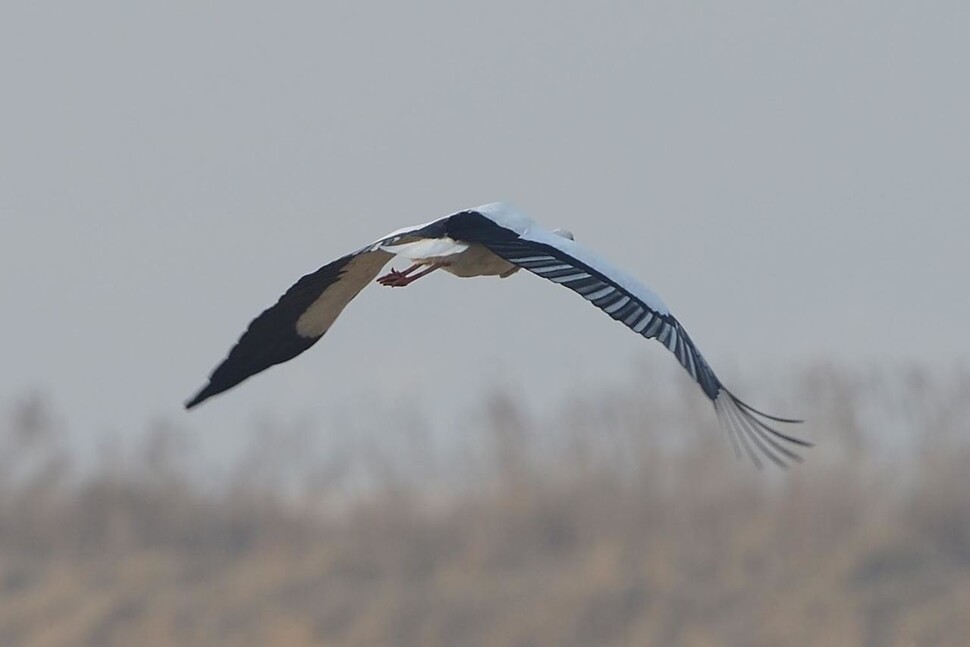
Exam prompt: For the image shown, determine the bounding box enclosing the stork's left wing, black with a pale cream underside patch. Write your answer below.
[185,248,393,409]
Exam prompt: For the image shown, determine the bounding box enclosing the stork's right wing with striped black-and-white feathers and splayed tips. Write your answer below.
[447,211,811,467]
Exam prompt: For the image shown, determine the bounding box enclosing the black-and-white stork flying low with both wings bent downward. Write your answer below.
[185,202,811,467]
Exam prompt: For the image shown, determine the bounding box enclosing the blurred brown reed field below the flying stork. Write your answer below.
[0,367,970,647]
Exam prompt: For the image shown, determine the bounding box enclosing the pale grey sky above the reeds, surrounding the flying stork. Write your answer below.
[0,0,970,464]
